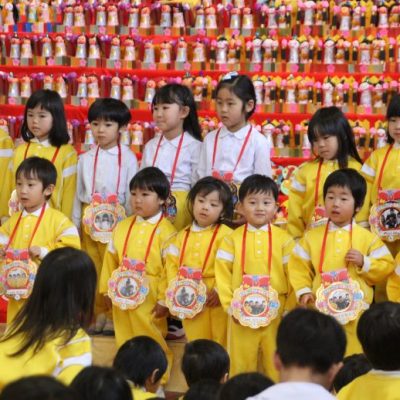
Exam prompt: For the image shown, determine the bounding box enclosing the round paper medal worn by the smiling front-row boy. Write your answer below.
[231,286,280,329]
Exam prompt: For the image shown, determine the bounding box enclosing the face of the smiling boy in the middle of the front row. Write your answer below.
[239,192,278,228]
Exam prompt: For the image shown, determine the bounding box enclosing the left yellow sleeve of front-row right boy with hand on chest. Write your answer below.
[288,236,315,299]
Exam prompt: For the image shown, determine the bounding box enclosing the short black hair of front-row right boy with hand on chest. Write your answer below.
[324,168,367,212]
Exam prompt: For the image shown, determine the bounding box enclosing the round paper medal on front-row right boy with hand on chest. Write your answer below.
[315,279,369,325]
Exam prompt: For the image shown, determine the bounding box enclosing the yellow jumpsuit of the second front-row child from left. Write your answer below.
[99,213,176,382]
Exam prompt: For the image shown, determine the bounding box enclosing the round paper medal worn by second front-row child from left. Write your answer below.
[108,267,149,310]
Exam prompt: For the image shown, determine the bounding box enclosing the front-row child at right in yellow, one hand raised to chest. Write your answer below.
[289,168,393,355]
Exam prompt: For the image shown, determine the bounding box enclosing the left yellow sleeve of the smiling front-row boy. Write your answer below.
[215,235,235,312]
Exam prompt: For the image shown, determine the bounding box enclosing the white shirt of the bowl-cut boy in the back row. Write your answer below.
[72,145,138,227]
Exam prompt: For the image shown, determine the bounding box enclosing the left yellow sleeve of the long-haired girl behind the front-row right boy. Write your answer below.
[287,168,307,239]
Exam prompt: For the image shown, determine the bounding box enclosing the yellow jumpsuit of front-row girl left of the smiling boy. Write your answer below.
[166,224,232,347]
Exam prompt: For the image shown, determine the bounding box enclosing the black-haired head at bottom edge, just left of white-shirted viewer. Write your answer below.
[218,372,274,400]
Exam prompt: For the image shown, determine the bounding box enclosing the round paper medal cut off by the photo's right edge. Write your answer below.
[369,201,400,242]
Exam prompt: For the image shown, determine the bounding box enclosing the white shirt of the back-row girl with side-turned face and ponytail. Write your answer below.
[140,132,201,191]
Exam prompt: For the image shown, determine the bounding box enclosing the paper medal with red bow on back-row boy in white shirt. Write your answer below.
[82,193,126,243]
